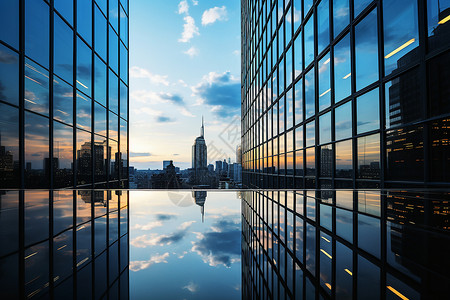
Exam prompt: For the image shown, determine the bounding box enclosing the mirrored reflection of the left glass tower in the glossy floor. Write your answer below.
[0,190,129,299]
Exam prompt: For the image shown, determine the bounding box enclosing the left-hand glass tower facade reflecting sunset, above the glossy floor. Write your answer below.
[0,0,129,188]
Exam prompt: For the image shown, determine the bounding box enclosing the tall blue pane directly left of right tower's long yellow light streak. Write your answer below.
[355,10,378,90]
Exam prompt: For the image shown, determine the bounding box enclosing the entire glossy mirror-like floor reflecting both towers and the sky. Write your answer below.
[0,190,450,299]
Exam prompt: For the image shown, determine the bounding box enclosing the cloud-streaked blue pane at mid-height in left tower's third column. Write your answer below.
[53,77,73,125]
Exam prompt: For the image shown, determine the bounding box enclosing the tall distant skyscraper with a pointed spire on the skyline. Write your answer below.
[191,118,208,185]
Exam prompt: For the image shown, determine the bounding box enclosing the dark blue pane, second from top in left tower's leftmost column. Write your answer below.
[0,44,19,105]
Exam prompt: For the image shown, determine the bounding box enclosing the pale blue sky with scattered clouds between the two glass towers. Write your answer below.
[130,0,240,169]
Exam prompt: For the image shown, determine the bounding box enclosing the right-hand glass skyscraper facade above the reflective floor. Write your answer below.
[241,0,450,188]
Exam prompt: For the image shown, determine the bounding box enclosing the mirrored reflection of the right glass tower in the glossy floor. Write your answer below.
[241,190,450,299]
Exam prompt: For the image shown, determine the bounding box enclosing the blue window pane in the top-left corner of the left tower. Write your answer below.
[0,0,19,49]
